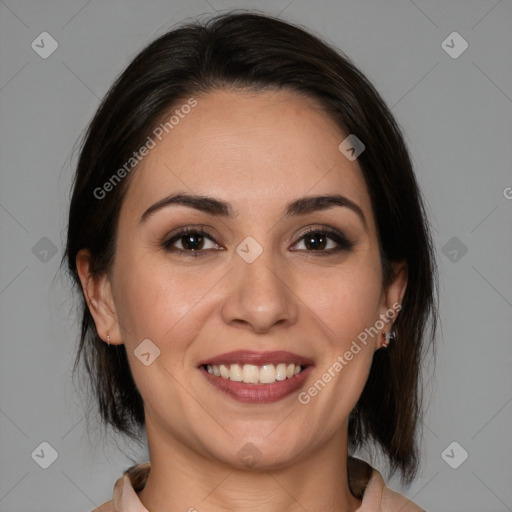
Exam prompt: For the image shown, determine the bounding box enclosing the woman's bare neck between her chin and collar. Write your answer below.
[139,425,361,512]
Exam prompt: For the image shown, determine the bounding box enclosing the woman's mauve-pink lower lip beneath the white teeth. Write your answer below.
[200,366,313,404]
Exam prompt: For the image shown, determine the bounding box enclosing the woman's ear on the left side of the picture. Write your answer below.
[76,249,122,345]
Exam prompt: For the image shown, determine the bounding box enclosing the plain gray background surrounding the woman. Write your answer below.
[0,0,512,512]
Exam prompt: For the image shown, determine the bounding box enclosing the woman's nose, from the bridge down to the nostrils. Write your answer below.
[222,246,298,334]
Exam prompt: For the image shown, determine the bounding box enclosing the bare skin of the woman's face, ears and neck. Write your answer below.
[77,90,407,512]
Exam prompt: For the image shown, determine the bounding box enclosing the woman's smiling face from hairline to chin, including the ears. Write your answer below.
[79,87,406,467]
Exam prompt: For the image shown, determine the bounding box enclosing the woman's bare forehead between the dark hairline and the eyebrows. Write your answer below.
[123,90,371,222]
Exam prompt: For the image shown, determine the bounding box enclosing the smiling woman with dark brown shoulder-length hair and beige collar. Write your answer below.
[66,9,436,512]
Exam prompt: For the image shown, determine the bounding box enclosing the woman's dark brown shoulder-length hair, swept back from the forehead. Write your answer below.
[63,12,437,483]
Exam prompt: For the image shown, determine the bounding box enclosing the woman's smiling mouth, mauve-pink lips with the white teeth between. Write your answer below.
[198,351,314,404]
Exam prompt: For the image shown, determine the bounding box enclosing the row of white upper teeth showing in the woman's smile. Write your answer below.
[206,363,301,384]
